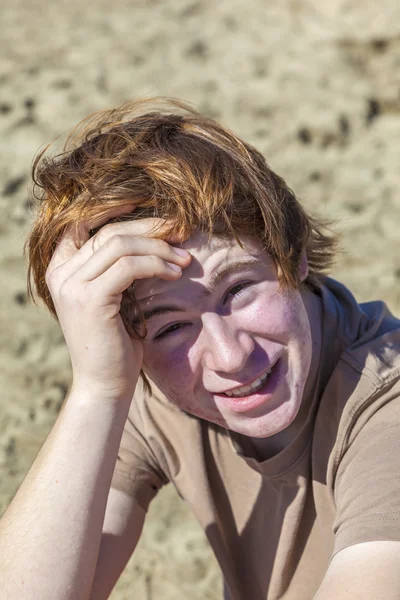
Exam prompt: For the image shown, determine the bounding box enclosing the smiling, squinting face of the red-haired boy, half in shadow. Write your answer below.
[135,234,322,438]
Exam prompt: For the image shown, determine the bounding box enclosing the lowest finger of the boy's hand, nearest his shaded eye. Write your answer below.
[88,256,182,298]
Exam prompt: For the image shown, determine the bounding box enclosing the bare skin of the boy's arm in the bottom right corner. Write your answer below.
[314,541,400,600]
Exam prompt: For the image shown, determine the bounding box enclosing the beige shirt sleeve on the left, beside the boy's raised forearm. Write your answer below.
[111,385,168,511]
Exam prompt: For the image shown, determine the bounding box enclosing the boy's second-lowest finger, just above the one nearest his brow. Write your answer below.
[77,235,191,281]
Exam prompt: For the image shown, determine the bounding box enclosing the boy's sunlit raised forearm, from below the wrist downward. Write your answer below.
[0,391,130,600]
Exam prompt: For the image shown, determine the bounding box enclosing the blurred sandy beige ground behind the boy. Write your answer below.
[0,0,400,600]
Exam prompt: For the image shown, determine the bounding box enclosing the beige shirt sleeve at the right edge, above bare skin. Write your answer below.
[334,385,400,554]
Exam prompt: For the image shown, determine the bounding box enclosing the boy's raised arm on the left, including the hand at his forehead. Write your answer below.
[0,206,190,600]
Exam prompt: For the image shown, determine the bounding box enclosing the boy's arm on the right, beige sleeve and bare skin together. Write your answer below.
[314,380,400,600]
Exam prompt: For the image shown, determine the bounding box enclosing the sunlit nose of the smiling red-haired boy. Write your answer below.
[201,313,255,373]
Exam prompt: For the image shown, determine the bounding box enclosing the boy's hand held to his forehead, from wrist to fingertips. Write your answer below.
[46,207,191,399]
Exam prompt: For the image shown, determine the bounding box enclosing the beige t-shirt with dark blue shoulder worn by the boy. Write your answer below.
[112,279,400,600]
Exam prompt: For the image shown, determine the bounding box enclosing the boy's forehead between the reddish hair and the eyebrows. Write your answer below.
[135,233,272,301]
